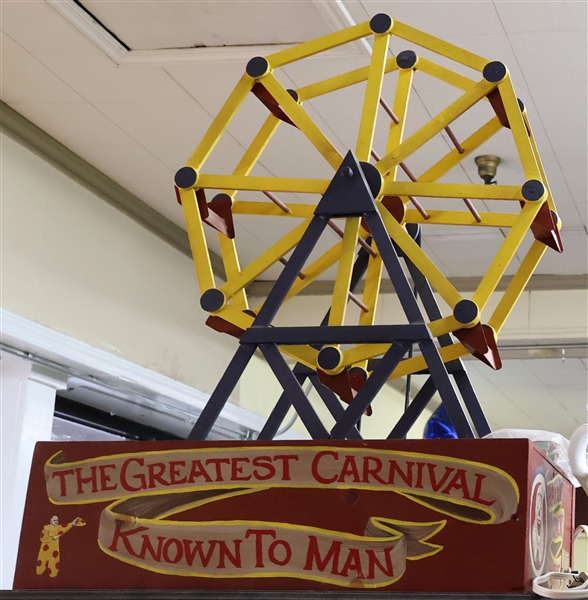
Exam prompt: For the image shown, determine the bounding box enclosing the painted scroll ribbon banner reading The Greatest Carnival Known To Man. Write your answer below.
[45,446,519,588]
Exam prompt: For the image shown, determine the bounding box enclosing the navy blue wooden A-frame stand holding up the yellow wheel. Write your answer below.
[188,151,490,440]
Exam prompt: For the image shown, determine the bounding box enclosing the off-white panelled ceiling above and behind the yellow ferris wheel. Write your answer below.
[0,0,588,438]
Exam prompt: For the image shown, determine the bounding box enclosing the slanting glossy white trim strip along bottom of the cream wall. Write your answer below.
[0,308,274,432]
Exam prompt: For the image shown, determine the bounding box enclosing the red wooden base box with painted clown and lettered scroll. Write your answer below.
[14,439,574,593]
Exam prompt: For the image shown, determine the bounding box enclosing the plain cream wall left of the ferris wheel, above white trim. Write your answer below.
[0,135,238,400]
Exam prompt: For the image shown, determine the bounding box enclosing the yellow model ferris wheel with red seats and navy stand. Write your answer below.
[175,14,562,439]
